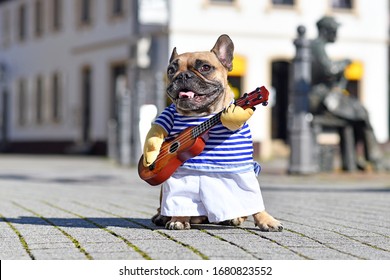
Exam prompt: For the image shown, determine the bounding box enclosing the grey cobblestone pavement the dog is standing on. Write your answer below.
[0,155,390,260]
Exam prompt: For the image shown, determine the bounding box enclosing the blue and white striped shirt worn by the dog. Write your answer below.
[154,104,260,175]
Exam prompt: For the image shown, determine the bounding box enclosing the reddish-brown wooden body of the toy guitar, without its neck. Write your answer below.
[138,127,208,186]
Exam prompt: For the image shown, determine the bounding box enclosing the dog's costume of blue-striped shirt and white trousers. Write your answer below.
[154,101,264,222]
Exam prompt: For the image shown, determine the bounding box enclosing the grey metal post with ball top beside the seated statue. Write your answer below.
[288,26,318,174]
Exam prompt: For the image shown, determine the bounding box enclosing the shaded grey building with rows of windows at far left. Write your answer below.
[0,0,131,153]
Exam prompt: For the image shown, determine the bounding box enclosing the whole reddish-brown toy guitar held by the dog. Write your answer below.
[138,86,269,186]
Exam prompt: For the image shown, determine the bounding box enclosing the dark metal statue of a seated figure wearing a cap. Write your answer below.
[309,16,383,170]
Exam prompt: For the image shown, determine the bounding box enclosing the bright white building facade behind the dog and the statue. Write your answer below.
[170,0,389,158]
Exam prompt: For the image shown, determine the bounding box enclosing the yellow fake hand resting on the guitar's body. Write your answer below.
[143,124,167,167]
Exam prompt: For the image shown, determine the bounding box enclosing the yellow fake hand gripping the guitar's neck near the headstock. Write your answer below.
[221,104,254,131]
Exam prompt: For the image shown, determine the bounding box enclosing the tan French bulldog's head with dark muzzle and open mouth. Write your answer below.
[167,35,234,116]
